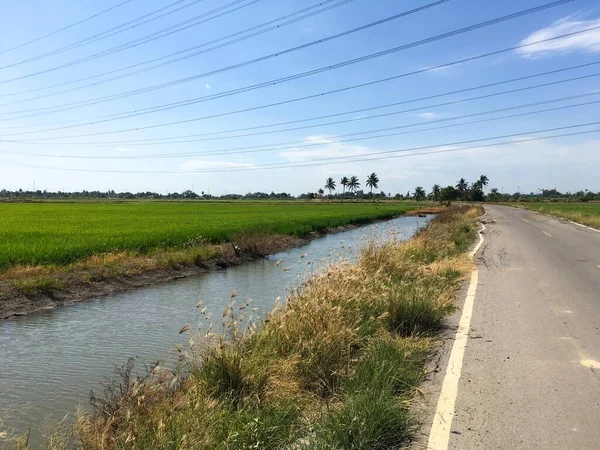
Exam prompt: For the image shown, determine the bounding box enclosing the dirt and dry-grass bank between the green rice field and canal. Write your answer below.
[0,219,400,319]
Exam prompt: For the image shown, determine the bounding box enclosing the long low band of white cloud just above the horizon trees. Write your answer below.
[5,136,600,194]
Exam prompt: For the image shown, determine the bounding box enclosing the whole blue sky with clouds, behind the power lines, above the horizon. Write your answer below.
[0,0,600,194]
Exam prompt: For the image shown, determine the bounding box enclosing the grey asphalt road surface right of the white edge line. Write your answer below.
[422,206,600,450]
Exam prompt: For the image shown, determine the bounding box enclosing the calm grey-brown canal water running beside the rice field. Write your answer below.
[0,216,431,437]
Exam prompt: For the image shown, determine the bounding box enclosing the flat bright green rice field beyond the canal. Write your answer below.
[0,201,414,270]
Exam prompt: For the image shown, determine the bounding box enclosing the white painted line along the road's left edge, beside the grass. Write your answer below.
[427,220,485,450]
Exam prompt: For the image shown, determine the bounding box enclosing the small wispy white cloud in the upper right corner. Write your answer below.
[517,17,600,58]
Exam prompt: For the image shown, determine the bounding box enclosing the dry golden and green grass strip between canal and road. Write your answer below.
[12,206,482,450]
